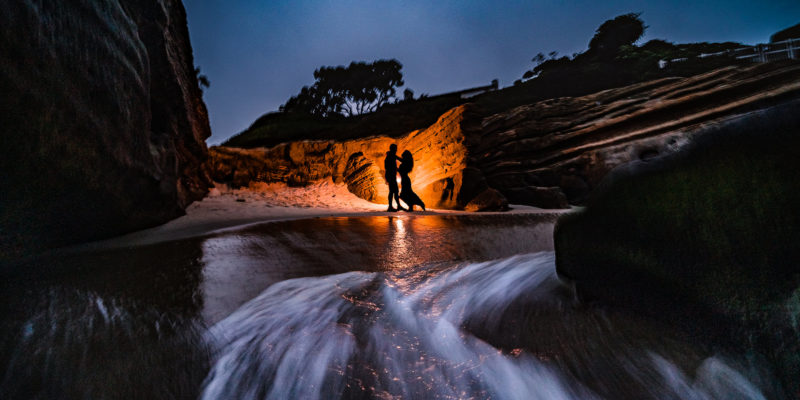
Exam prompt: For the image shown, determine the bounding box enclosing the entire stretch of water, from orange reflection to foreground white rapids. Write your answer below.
[0,215,779,399]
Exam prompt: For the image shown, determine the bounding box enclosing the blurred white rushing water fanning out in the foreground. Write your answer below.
[201,252,764,399]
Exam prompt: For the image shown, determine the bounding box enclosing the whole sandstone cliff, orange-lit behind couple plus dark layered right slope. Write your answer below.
[211,63,800,210]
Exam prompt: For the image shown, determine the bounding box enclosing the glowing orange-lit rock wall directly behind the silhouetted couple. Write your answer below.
[209,106,507,211]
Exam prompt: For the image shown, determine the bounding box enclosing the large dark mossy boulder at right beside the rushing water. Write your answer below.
[555,100,800,394]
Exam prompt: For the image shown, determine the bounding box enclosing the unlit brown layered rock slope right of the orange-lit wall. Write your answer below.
[465,62,800,208]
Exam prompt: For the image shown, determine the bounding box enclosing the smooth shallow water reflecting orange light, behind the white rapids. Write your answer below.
[200,214,556,323]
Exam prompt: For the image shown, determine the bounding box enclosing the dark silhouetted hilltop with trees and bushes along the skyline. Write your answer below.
[223,14,756,148]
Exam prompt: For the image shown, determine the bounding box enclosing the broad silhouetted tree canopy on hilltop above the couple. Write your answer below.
[280,59,403,117]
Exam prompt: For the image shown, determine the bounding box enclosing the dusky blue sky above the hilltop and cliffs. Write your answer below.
[184,0,800,144]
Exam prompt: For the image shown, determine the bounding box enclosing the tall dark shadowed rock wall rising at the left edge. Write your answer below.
[0,0,210,259]
